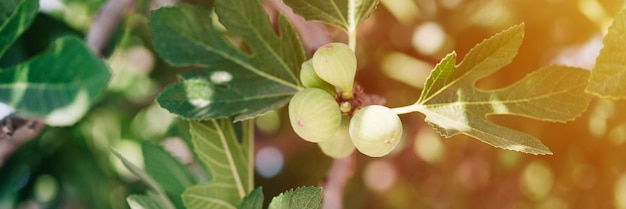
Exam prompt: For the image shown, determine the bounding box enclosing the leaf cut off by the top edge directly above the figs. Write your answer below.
[283,0,378,31]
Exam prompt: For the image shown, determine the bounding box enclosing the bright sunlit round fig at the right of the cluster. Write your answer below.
[350,105,402,157]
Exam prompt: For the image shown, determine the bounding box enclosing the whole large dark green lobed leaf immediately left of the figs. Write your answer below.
[150,0,305,121]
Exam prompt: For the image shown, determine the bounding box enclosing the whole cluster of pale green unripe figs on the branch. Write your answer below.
[289,43,402,158]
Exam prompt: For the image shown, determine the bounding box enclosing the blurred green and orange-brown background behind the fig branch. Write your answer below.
[0,0,626,209]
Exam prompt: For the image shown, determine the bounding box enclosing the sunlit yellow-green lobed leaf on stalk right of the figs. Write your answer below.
[410,24,591,154]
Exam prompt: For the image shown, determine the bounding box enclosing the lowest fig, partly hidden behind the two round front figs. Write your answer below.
[317,116,354,159]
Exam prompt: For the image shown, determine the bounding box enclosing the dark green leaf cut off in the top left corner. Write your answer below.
[0,0,39,56]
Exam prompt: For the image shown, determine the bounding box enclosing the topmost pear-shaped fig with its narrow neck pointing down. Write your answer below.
[312,43,356,99]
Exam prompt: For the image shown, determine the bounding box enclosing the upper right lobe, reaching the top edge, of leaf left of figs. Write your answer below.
[215,0,305,84]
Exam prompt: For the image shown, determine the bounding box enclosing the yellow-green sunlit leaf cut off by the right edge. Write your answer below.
[586,10,626,99]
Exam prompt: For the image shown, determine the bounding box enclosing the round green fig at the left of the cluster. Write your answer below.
[289,88,341,142]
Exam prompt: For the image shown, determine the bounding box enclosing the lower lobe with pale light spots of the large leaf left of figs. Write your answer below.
[157,67,294,121]
